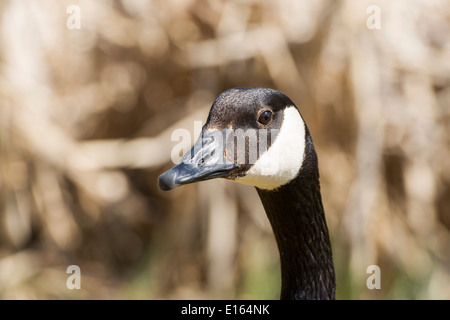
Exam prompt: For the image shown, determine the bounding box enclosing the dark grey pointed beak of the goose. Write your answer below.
[159,129,238,191]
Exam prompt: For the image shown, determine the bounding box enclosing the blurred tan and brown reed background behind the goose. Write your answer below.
[0,0,450,299]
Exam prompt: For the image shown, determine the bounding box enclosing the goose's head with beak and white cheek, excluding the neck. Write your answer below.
[159,88,307,190]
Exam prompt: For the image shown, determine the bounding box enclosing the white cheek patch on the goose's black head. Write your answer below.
[234,106,305,190]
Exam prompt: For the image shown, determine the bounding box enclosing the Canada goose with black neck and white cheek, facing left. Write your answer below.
[159,88,336,300]
